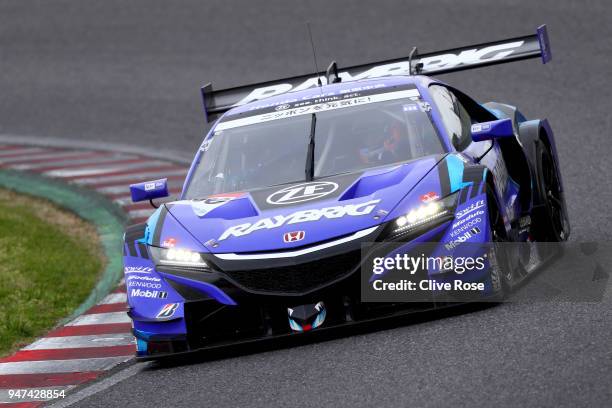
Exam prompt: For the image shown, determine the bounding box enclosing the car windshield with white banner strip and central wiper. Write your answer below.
[185,89,444,199]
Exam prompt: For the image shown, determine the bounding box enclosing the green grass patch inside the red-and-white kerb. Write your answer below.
[0,190,104,356]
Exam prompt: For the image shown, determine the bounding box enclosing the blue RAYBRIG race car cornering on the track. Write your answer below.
[124,26,569,358]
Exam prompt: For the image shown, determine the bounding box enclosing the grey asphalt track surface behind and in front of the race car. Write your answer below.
[0,0,612,407]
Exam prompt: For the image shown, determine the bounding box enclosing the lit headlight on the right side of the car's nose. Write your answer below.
[386,193,457,239]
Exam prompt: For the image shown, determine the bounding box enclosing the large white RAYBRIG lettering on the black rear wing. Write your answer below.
[234,41,525,106]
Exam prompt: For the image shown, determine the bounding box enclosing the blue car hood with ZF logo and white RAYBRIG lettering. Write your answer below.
[160,155,444,253]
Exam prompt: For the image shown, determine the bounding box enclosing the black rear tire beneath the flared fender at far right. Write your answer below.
[531,143,569,242]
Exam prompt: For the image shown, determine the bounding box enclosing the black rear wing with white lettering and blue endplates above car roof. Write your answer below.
[202,25,552,122]
